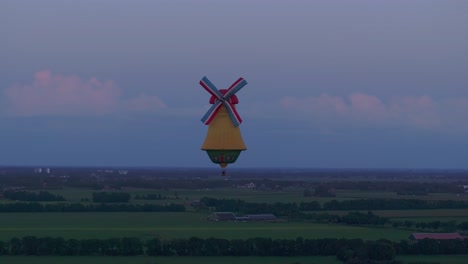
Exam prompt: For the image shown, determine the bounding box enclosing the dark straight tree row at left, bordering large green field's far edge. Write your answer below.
[0,203,185,213]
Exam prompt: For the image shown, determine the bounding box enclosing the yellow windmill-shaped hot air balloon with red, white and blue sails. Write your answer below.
[200,76,247,176]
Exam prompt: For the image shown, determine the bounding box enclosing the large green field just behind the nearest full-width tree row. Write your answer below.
[0,212,411,241]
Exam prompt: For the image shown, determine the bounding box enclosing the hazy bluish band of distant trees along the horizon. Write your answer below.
[0,167,467,194]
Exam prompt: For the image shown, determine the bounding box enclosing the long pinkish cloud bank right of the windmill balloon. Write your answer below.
[279,93,468,131]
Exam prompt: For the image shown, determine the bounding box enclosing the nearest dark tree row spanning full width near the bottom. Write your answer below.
[0,236,468,256]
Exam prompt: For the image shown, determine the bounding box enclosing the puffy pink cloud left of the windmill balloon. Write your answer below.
[5,70,166,116]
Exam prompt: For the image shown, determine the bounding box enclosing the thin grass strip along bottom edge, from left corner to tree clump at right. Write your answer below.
[0,256,342,264]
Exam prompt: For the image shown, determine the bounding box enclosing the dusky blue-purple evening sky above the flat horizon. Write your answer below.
[0,0,468,169]
